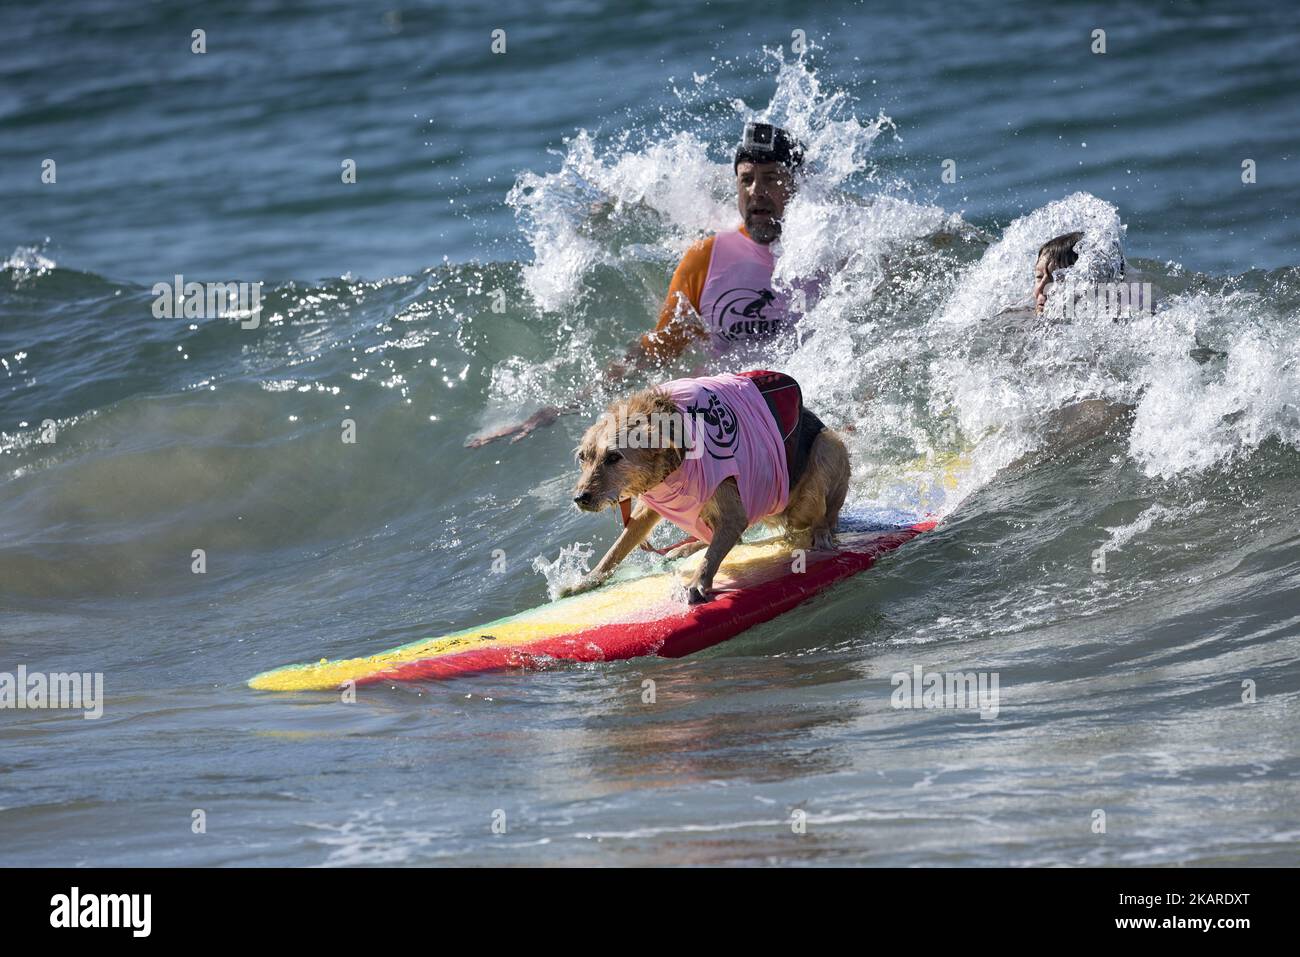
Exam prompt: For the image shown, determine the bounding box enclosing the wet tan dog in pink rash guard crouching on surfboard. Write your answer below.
[564,372,849,605]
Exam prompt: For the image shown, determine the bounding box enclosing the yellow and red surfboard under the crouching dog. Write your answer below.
[248,508,935,692]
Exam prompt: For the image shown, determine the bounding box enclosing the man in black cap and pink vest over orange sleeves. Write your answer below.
[465,122,803,449]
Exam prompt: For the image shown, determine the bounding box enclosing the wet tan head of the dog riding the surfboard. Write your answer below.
[573,389,681,512]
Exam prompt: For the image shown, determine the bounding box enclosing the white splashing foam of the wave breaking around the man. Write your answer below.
[491,56,1300,538]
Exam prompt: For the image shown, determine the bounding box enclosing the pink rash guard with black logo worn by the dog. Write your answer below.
[641,373,789,542]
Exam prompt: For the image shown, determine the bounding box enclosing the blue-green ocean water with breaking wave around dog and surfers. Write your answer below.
[0,0,1300,866]
